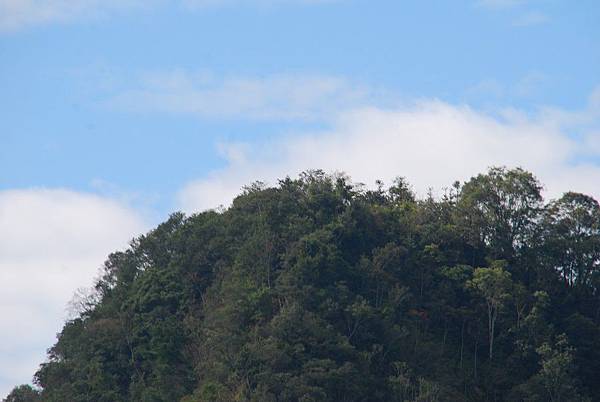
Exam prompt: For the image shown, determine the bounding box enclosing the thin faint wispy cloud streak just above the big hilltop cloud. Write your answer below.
[108,71,373,120]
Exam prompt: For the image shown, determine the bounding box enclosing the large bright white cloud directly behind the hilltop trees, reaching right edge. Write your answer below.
[179,90,600,211]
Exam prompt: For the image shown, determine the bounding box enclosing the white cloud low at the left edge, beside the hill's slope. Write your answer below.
[0,189,145,396]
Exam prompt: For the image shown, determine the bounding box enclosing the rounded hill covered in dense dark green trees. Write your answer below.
[7,168,600,402]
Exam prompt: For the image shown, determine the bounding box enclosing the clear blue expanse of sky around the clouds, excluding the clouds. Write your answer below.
[0,0,600,213]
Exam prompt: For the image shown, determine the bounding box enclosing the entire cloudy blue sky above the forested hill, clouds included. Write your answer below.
[0,0,600,397]
